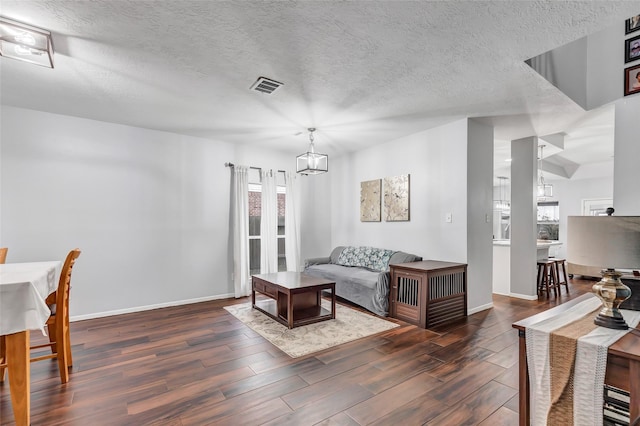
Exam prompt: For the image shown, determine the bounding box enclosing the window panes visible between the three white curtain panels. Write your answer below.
[249,183,287,275]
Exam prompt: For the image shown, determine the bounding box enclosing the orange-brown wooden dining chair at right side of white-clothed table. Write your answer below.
[31,248,80,383]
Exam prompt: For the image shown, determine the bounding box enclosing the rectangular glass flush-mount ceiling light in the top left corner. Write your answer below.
[0,17,53,68]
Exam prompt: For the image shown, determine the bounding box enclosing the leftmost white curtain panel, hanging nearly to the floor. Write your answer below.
[231,166,251,297]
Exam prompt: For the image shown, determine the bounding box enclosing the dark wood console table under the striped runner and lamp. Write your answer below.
[513,294,640,426]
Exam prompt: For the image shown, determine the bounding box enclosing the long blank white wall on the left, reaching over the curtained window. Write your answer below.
[0,106,329,317]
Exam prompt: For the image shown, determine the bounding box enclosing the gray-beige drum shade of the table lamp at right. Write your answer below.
[567,216,640,270]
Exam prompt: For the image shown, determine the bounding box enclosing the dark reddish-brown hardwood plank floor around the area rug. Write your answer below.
[0,279,593,426]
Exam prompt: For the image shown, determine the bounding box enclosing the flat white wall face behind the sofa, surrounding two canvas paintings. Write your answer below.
[328,119,467,262]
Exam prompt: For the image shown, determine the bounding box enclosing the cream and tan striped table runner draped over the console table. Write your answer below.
[525,296,640,426]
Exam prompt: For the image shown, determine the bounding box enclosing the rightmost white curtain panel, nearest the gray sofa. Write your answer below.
[284,172,300,272]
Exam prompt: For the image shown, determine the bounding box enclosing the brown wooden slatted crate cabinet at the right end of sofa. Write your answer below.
[389,260,467,328]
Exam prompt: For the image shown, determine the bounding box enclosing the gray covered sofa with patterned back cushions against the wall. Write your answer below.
[304,246,422,316]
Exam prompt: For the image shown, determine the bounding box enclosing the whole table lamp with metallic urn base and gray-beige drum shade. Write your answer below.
[567,216,640,330]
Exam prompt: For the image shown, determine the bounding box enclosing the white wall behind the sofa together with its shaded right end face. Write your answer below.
[328,119,493,310]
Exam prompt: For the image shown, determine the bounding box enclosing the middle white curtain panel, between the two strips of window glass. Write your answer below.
[260,170,278,274]
